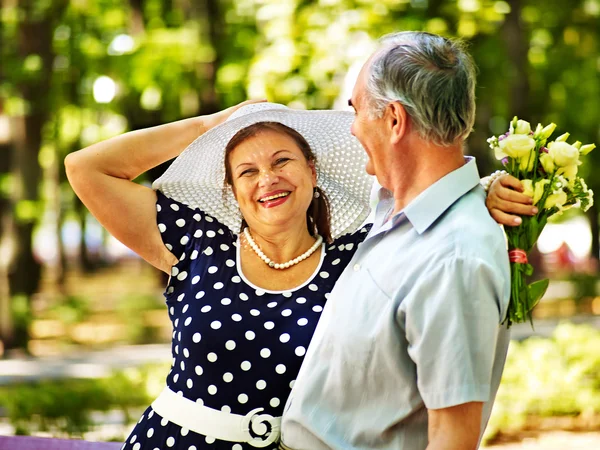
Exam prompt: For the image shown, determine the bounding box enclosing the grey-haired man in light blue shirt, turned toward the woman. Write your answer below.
[282,32,510,450]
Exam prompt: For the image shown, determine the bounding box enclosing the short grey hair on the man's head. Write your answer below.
[366,31,476,146]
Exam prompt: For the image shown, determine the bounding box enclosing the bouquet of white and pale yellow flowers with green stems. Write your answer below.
[488,117,596,327]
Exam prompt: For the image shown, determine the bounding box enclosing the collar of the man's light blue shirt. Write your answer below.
[371,156,479,234]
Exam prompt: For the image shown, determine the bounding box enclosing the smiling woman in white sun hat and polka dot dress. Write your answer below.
[65,102,529,450]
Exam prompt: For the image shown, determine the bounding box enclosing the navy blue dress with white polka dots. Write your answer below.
[123,192,367,450]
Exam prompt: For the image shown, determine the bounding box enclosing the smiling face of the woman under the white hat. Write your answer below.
[228,130,317,228]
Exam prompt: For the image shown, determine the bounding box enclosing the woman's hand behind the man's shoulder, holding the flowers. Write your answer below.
[485,175,538,227]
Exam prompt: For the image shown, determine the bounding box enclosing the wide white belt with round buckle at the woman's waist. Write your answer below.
[152,387,281,447]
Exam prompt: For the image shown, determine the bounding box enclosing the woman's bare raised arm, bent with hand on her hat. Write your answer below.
[65,100,262,273]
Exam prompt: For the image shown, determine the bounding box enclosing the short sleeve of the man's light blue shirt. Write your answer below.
[399,258,508,409]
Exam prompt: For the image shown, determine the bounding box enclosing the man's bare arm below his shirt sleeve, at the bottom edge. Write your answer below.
[427,402,483,450]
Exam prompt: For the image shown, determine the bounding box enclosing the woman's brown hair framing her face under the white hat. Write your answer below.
[225,122,332,242]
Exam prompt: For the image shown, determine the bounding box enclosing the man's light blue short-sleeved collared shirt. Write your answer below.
[282,158,510,450]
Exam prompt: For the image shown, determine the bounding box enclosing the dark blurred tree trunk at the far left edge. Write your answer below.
[8,0,68,348]
